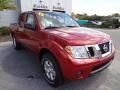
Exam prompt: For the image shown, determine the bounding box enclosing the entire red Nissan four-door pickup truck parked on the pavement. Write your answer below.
[10,11,115,87]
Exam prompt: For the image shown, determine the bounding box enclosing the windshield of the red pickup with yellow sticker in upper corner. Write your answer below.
[38,12,79,29]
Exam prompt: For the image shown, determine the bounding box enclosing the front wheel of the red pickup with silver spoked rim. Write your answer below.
[41,53,63,87]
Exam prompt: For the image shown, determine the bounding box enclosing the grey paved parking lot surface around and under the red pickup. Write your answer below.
[0,29,120,90]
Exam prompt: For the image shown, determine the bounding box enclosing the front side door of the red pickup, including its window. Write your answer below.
[24,13,40,54]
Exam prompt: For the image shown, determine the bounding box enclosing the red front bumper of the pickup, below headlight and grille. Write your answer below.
[61,49,115,80]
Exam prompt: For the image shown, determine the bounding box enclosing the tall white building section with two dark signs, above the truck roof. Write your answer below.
[16,0,72,14]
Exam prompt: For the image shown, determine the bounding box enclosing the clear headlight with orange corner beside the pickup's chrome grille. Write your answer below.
[65,46,89,59]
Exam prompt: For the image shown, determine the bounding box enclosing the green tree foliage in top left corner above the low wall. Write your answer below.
[0,0,15,11]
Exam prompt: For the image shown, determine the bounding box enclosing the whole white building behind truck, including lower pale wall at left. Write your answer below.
[0,0,72,27]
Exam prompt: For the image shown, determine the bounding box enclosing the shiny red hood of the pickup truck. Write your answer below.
[47,27,110,45]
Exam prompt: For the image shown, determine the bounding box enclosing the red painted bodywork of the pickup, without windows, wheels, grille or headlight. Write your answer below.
[10,12,115,80]
